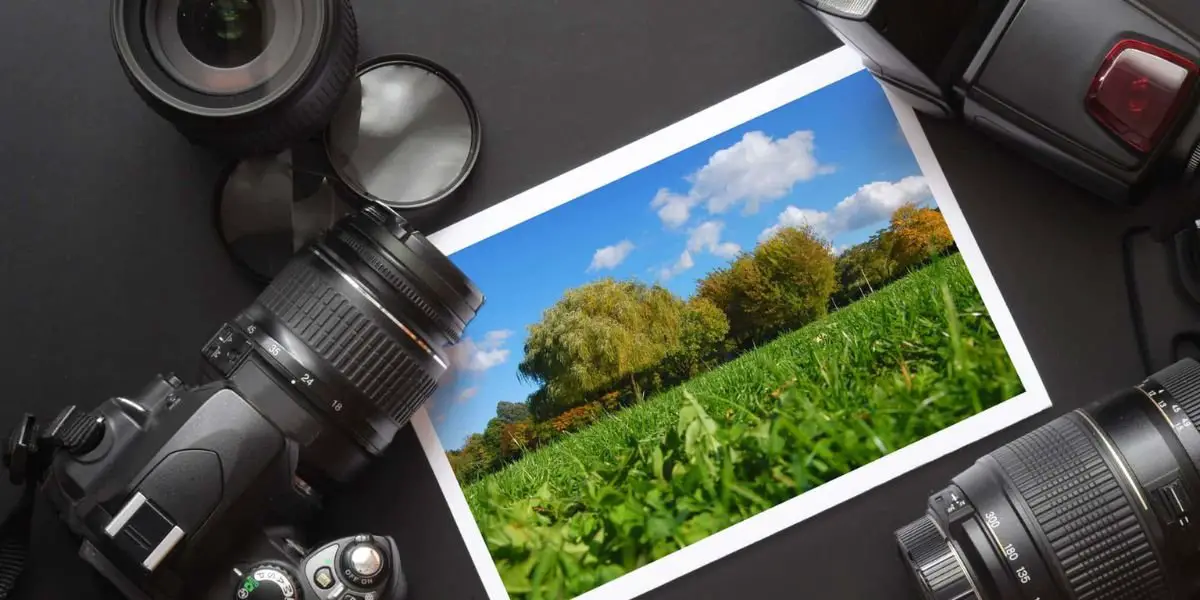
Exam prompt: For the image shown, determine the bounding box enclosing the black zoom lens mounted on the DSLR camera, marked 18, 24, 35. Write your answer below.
[204,205,484,480]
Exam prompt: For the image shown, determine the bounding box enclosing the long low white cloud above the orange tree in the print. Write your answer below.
[758,175,930,241]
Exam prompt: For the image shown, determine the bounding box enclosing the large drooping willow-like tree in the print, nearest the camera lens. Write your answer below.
[517,278,684,415]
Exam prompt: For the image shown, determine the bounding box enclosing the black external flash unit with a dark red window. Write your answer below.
[803,0,1200,204]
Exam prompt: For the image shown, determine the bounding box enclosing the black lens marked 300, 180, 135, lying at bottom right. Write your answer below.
[896,359,1200,600]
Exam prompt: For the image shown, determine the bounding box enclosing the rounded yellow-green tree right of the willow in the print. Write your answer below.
[697,227,838,348]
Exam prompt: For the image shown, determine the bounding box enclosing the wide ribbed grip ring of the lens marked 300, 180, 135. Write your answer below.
[992,415,1165,600]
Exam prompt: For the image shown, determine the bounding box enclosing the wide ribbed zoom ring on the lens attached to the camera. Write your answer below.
[258,256,436,425]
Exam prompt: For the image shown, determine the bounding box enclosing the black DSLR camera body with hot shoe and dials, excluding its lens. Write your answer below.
[42,377,406,600]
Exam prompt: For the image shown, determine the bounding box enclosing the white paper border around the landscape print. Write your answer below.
[412,47,1051,600]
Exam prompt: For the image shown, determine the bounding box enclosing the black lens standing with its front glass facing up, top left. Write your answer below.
[112,0,359,156]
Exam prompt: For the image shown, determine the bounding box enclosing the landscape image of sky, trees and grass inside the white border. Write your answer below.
[428,66,1024,599]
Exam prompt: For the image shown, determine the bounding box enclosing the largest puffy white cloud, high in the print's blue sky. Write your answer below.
[689,131,833,215]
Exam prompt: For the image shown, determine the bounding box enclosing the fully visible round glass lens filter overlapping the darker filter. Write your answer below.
[325,55,481,210]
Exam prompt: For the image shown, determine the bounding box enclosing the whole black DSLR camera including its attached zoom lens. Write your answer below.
[7,205,484,600]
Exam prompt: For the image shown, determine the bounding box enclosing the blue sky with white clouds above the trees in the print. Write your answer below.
[430,72,932,449]
